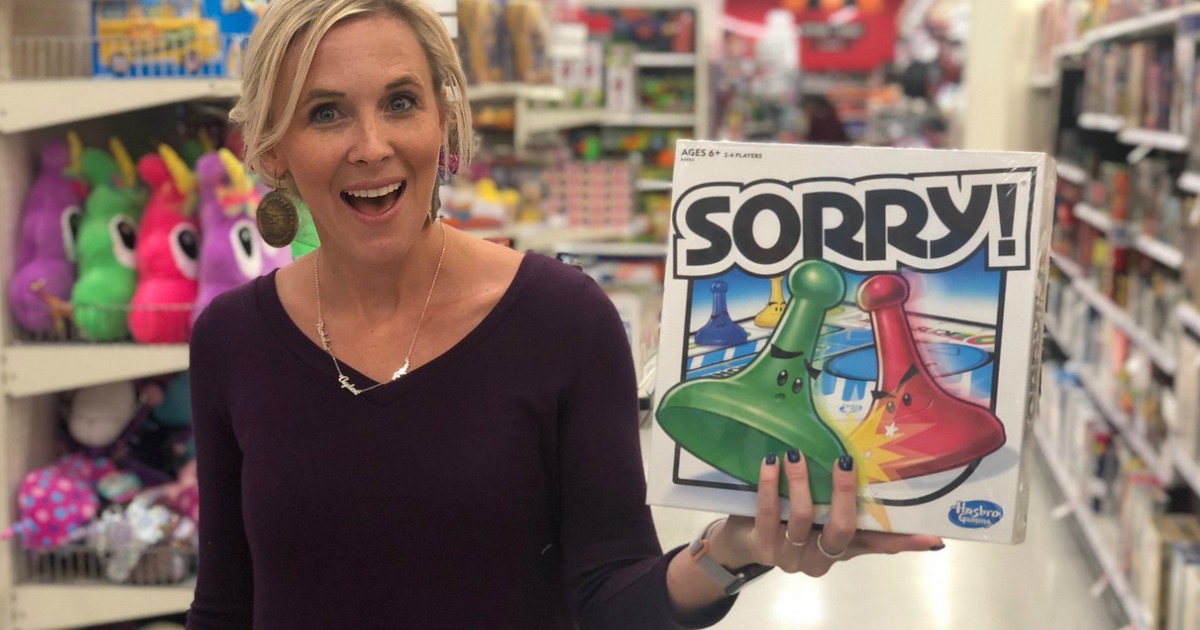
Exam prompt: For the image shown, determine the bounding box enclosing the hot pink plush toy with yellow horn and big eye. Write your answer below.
[128,144,200,343]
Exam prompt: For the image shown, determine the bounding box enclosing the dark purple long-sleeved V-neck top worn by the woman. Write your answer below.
[187,254,732,630]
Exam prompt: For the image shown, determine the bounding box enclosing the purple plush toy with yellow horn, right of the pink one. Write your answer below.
[192,149,290,322]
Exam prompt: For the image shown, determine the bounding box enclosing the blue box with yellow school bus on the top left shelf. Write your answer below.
[92,0,265,78]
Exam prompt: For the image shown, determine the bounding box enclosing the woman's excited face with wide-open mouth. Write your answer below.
[264,13,443,262]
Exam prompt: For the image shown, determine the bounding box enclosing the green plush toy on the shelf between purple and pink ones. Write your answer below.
[71,138,144,341]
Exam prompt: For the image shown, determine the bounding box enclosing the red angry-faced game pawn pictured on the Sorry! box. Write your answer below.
[858,274,1006,481]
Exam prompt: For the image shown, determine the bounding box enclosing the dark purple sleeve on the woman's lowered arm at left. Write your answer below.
[187,303,253,630]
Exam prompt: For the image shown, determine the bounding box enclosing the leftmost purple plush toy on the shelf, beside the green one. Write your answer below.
[8,133,83,338]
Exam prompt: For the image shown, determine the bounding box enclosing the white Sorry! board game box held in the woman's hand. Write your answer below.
[648,140,1055,542]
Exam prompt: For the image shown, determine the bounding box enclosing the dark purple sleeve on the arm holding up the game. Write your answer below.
[559,277,733,630]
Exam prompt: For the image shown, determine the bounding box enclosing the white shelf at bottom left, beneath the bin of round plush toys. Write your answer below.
[11,582,196,630]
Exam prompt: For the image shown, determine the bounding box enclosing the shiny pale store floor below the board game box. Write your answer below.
[643,431,1123,630]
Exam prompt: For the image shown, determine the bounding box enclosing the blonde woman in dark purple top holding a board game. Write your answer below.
[188,0,940,630]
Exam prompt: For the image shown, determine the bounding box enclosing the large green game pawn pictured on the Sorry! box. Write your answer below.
[655,260,846,504]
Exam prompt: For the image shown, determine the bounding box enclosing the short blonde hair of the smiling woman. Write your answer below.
[229,0,475,196]
